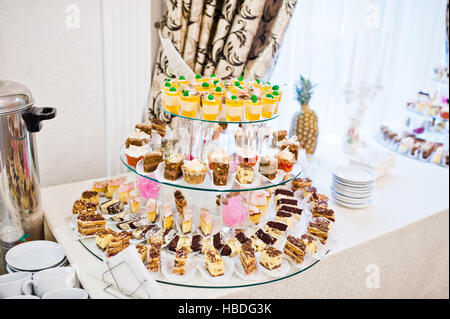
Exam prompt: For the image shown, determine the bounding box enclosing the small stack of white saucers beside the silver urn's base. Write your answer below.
[5,240,67,273]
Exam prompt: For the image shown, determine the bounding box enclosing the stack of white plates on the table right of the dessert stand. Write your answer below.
[331,165,376,208]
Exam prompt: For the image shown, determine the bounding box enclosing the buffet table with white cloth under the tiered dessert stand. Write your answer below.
[43,141,449,299]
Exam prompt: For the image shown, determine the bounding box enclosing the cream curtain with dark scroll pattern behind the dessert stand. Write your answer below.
[148,0,297,122]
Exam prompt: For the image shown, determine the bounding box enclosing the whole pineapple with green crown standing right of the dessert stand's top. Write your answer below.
[293,75,319,154]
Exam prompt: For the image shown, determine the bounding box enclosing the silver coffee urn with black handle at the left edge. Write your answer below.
[0,80,56,272]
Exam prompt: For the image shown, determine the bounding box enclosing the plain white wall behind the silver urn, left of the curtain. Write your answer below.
[0,0,106,186]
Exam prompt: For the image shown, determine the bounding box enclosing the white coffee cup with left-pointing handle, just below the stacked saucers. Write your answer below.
[22,267,76,297]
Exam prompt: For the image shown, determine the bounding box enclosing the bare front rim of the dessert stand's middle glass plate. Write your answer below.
[120,148,302,193]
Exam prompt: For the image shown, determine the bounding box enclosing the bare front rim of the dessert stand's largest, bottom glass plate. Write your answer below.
[79,238,330,289]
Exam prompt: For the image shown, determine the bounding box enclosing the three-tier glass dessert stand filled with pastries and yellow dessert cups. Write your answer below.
[69,75,336,288]
